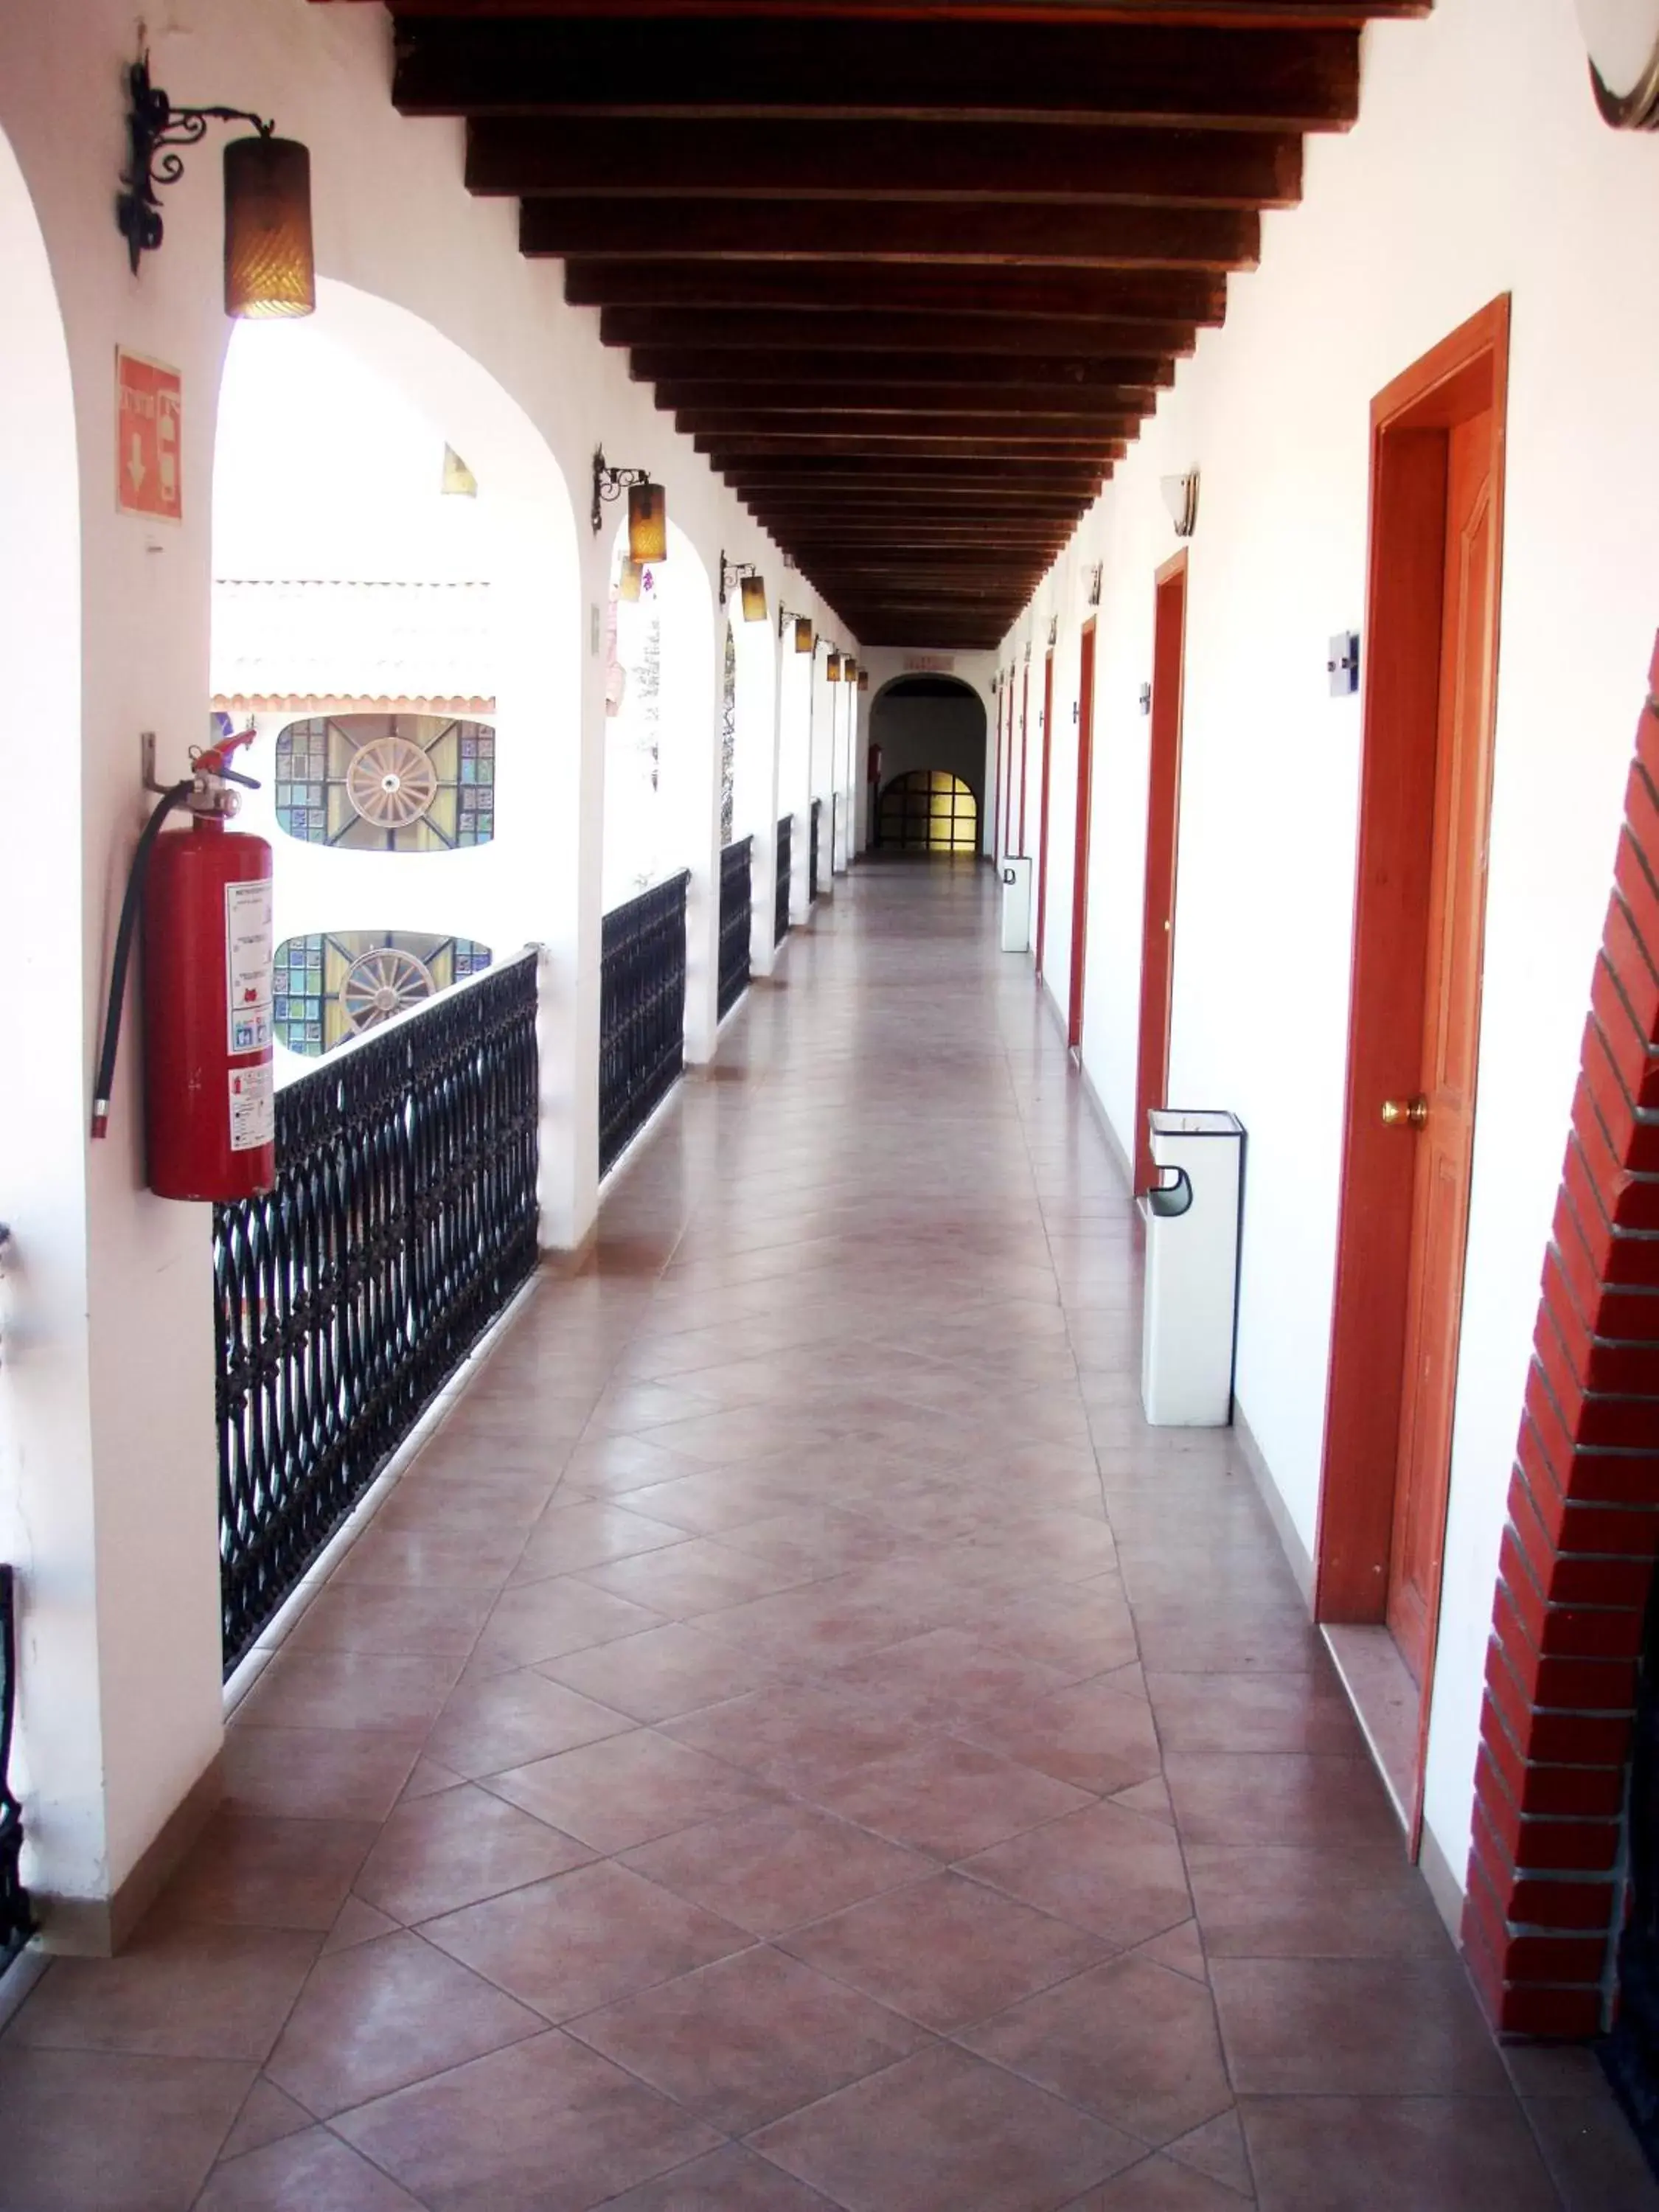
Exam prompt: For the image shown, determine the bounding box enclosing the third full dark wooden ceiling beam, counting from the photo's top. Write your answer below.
[518,199,1261,272]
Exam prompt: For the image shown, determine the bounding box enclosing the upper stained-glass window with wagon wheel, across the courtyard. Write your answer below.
[276,714,495,852]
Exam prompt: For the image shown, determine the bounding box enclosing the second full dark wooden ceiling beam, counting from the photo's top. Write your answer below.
[467,115,1303,208]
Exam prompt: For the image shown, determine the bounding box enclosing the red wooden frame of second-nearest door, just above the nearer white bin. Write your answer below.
[1133,546,1188,1197]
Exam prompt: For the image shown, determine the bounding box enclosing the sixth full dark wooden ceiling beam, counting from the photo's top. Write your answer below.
[628,347,1175,392]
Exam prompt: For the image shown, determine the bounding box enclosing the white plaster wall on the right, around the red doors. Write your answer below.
[1013,0,1659,1874]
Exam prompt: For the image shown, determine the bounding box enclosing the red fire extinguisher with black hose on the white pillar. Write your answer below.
[93,730,276,1199]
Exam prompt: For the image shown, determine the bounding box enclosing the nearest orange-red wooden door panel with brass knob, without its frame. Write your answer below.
[1389,411,1498,1681]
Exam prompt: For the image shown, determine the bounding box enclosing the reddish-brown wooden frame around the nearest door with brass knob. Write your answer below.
[1314,294,1509,1851]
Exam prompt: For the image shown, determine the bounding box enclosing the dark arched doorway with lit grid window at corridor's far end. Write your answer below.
[869,675,987,852]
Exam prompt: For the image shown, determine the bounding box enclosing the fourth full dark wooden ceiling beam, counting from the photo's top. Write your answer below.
[564,257,1228,321]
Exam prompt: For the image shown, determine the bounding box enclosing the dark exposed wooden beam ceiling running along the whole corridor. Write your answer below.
[389,0,1429,650]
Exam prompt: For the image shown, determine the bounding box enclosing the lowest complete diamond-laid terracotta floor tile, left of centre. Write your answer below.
[568,1944,929,2135]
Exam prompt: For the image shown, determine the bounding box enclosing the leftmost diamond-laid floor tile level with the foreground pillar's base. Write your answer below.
[354,1783,593,1922]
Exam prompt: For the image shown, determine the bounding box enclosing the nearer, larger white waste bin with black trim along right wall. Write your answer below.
[1139,1106,1245,1429]
